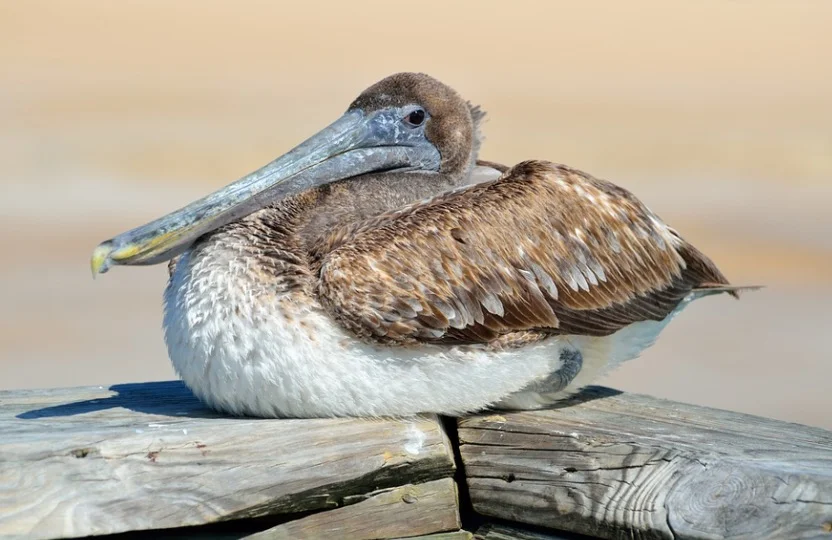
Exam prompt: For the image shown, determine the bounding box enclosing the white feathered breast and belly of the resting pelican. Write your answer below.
[159,167,684,417]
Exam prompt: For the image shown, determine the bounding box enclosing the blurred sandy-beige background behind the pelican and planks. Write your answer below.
[0,0,832,428]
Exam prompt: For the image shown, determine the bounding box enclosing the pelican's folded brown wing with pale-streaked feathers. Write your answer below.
[318,161,727,343]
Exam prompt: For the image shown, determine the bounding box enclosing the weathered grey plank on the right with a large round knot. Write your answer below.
[459,388,832,539]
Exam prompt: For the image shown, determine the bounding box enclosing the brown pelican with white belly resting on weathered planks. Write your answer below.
[92,73,738,417]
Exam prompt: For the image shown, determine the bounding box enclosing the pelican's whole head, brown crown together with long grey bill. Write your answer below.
[91,73,481,276]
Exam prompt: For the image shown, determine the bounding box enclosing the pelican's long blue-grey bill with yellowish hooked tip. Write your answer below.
[90,107,440,277]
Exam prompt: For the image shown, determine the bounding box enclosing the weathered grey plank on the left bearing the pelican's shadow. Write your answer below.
[0,382,454,538]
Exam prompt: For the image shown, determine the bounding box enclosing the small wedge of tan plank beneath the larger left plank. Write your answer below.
[246,478,460,540]
